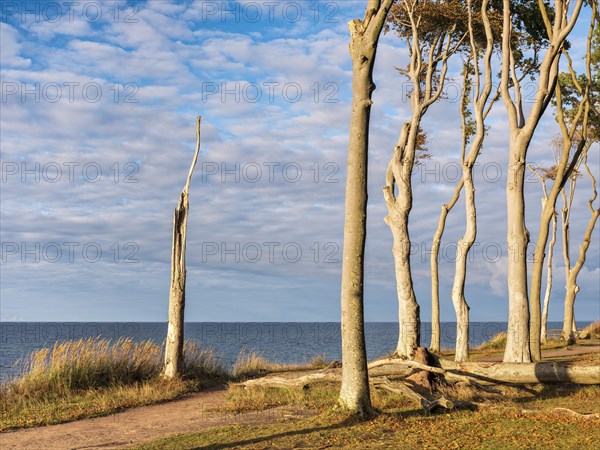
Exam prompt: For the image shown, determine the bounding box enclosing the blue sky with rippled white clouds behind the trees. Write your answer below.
[0,0,600,322]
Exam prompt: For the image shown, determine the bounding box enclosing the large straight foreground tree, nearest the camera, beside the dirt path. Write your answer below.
[339,0,393,416]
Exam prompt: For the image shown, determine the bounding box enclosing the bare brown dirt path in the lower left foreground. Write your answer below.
[0,387,311,450]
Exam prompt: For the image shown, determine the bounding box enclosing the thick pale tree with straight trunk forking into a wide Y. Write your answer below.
[500,0,583,362]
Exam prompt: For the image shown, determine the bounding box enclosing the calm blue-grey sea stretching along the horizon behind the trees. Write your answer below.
[0,322,587,379]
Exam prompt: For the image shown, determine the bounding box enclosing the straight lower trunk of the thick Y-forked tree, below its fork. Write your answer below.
[504,133,531,362]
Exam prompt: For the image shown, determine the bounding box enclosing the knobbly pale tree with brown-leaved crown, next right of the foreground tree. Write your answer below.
[383,0,465,358]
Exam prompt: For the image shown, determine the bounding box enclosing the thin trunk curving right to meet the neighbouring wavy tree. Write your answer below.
[429,178,464,353]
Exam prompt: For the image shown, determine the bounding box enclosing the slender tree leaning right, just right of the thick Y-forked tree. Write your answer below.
[529,0,597,361]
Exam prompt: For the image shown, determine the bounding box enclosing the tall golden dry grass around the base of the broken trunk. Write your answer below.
[0,338,229,430]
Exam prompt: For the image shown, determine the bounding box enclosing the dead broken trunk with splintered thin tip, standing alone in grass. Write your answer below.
[162,117,201,379]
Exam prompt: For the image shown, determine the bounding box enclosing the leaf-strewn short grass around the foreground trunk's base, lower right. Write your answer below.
[138,383,600,450]
